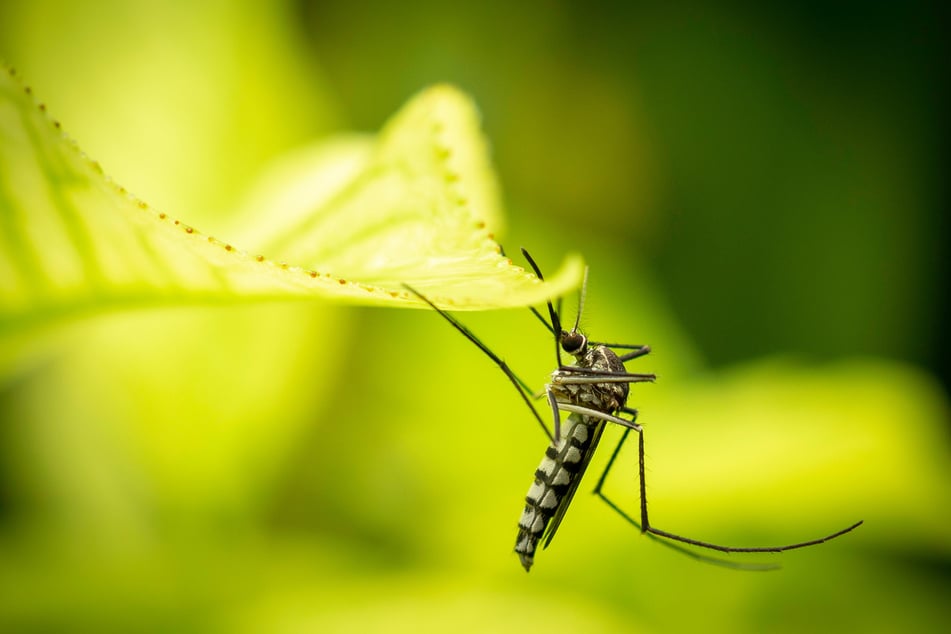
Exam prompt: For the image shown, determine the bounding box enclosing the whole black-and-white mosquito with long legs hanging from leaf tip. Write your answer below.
[404,249,862,572]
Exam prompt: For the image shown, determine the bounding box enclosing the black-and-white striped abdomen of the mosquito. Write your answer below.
[515,414,604,571]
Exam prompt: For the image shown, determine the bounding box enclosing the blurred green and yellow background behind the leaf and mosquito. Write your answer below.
[0,0,951,632]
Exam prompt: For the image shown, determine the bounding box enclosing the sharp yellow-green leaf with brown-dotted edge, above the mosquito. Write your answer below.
[0,64,582,338]
